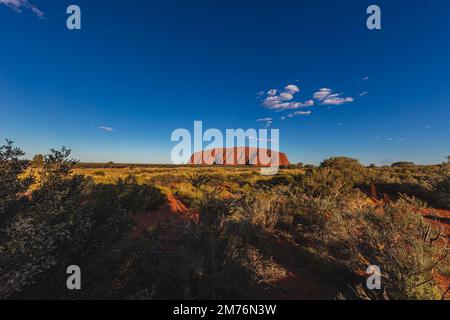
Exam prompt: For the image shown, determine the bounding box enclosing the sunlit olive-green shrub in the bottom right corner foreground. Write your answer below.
[344,197,450,299]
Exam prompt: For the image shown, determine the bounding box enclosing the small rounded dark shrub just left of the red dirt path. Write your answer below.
[117,175,166,213]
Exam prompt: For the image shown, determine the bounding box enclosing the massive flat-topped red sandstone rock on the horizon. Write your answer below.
[189,147,289,167]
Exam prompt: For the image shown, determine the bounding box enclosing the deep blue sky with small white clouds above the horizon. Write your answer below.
[0,0,450,164]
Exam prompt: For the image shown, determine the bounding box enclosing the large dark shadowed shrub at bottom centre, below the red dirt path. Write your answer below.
[141,198,259,299]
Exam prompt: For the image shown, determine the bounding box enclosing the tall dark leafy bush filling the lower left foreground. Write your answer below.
[0,148,91,297]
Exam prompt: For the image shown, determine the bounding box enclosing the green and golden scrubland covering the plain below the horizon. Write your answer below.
[0,142,450,299]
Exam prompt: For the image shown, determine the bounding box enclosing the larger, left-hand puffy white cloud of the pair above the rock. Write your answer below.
[262,84,314,111]
